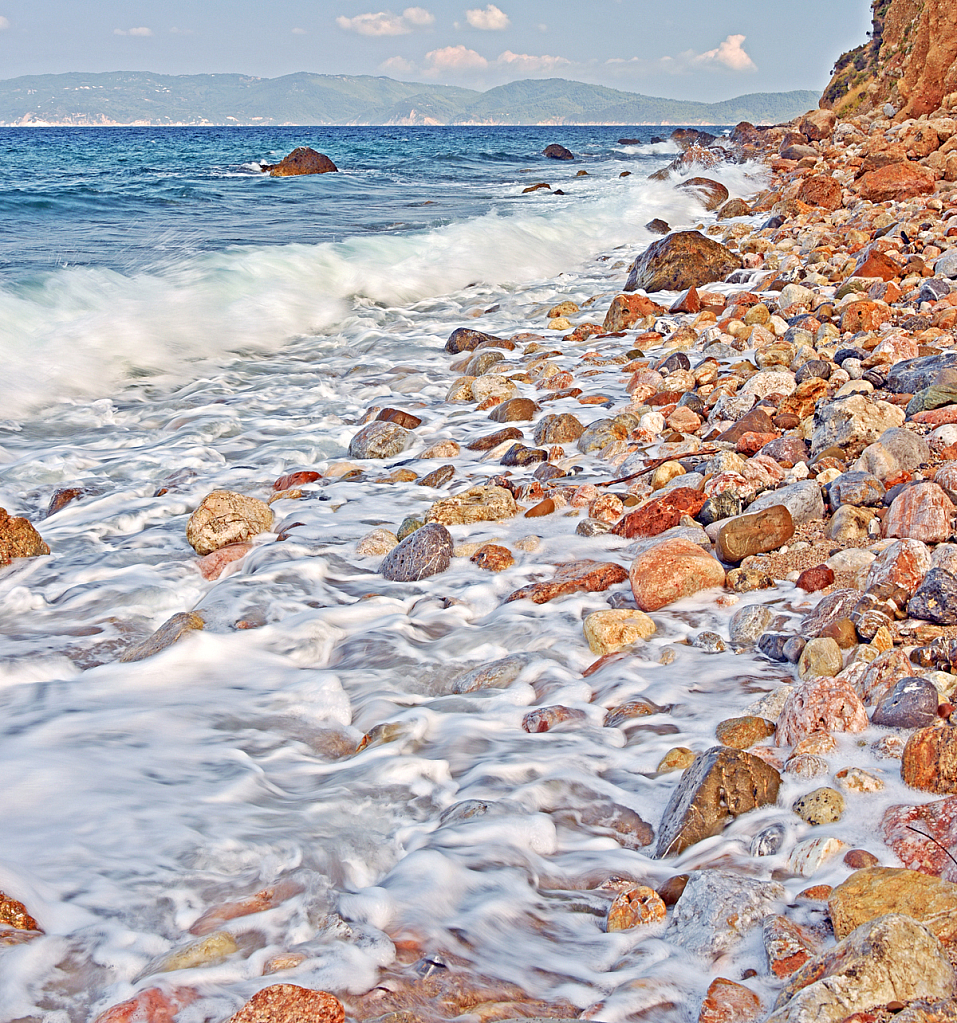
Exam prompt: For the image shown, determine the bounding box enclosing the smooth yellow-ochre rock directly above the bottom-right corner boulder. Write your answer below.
[828,866,957,944]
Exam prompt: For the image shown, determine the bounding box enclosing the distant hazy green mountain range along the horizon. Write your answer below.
[0,72,818,126]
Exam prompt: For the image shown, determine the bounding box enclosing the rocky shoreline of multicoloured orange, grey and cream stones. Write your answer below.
[9,99,957,1023]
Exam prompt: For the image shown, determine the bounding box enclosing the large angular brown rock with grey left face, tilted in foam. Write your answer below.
[655,746,781,858]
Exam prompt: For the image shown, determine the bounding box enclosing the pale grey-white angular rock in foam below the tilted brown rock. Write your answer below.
[664,870,786,959]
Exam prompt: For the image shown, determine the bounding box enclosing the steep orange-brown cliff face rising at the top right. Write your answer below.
[821,0,957,121]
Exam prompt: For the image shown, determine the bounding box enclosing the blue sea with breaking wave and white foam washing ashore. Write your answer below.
[0,126,894,1023]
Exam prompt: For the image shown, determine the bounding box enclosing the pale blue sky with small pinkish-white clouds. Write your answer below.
[0,0,870,101]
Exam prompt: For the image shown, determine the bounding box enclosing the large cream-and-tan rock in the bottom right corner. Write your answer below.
[767,914,954,1023]
